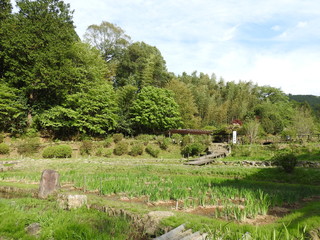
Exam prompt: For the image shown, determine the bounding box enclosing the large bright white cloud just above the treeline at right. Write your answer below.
[212,49,320,95]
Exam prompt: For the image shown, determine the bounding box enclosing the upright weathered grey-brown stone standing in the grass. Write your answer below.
[38,169,60,198]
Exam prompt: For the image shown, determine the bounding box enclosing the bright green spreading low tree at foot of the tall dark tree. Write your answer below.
[36,83,118,137]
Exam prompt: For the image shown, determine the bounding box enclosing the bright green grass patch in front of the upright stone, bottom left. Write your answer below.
[0,198,140,239]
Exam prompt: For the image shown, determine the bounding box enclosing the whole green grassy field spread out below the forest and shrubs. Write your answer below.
[0,140,320,240]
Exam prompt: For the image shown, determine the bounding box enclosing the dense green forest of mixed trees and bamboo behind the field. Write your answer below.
[0,0,320,138]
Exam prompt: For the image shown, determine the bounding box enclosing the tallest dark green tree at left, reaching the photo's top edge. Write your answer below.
[2,0,78,122]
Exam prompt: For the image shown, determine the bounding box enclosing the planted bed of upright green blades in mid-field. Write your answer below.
[65,173,320,220]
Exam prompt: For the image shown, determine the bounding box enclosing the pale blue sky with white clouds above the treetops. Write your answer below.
[10,0,320,96]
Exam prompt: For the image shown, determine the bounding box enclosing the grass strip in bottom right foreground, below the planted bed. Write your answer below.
[162,202,320,240]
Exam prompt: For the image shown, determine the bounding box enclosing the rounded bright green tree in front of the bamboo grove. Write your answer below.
[131,86,182,132]
